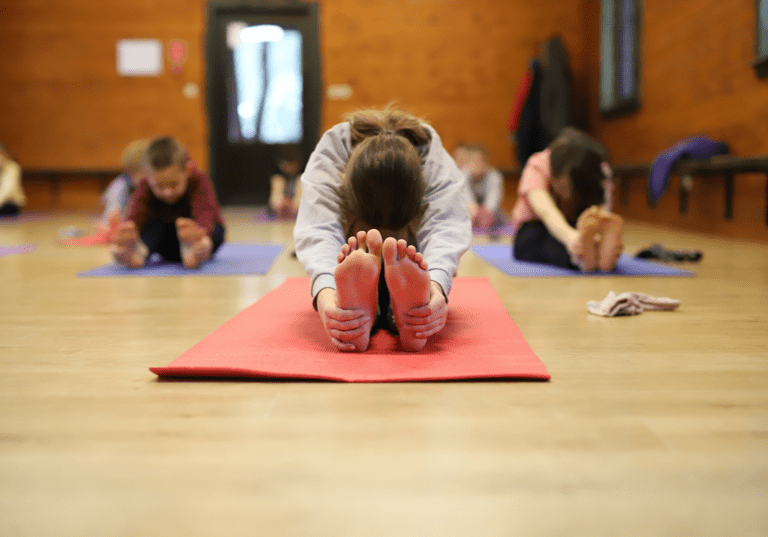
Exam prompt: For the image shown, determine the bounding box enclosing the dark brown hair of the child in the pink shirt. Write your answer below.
[549,127,608,224]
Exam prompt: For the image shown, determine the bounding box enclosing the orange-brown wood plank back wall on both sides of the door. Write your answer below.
[0,0,587,208]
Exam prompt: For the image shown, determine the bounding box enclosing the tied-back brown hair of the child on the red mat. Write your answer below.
[339,105,431,230]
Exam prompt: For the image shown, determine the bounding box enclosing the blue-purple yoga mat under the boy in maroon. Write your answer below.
[77,242,284,278]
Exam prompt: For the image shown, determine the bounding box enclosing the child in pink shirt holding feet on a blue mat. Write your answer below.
[512,127,623,272]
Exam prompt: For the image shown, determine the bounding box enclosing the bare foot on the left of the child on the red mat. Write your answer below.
[334,229,382,352]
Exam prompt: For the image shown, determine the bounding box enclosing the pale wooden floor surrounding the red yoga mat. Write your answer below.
[0,210,768,537]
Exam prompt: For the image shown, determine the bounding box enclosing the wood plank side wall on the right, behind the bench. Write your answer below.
[586,0,768,241]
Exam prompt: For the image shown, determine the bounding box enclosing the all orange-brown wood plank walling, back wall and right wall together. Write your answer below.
[0,0,768,240]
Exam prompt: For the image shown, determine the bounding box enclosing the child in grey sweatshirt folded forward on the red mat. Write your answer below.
[294,106,472,351]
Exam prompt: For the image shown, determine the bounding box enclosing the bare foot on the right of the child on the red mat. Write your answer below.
[382,237,430,351]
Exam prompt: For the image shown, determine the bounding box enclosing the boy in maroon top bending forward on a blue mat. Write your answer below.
[110,137,224,269]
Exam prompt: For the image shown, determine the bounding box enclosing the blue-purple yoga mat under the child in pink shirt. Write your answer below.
[472,244,694,276]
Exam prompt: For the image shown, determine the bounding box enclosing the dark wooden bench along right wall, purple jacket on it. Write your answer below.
[613,155,768,225]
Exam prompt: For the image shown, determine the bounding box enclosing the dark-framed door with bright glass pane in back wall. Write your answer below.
[205,0,321,205]
